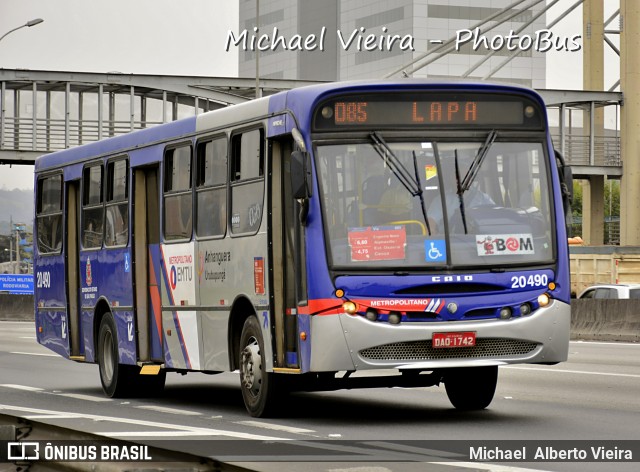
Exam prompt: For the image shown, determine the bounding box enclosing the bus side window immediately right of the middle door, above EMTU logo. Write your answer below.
[164,145,193,241]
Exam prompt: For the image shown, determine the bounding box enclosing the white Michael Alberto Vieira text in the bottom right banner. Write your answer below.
[469,446,634,462]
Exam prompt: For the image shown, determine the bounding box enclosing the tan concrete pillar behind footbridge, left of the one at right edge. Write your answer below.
[582,0,604,245]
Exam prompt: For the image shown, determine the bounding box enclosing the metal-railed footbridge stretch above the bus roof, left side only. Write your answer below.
[0,69,318,164]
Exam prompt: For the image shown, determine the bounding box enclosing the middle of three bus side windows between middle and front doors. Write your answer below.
[196,137,227,237]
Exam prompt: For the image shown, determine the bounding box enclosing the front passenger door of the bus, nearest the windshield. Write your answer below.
[270,140,306,369]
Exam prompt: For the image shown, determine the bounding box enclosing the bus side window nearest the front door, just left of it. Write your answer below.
[231,129,264,234]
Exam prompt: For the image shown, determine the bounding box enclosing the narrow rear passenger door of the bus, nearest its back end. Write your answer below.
[63,180,84,358]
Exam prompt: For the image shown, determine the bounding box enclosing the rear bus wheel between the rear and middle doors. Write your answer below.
[97,313,137,398]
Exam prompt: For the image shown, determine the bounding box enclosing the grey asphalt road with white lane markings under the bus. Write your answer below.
[0,322,640,472]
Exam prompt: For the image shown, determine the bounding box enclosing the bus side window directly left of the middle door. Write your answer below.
[104,159,129,247]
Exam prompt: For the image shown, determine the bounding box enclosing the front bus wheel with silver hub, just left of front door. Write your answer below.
[238,316,277,418]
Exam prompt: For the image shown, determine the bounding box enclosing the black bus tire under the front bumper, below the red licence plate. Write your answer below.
[443,366,498,411]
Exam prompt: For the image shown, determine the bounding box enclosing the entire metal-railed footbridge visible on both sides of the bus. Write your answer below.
[0,69,622,167]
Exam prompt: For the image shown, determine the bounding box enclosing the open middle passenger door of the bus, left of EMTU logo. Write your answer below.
[132,166,164,362]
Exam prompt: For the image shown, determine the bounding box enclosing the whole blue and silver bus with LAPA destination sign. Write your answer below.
[34,80,570,416]
